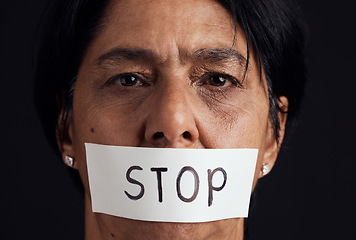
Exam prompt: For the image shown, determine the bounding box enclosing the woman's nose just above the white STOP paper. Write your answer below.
[145,81,199,148]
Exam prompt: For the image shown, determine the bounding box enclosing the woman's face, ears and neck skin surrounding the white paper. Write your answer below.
[57,0,287,240]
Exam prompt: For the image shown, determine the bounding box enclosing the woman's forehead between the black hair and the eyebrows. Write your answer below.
[84,0,244,62]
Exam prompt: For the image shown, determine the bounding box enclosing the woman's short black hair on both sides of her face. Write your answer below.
[34,0,306,156]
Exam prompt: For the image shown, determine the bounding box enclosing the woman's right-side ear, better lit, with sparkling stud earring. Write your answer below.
[259,96,288,178]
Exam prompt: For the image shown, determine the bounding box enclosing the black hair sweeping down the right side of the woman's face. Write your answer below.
[219,0,306,141]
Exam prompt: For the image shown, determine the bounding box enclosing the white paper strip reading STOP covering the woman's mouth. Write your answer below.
[85,143,258,223]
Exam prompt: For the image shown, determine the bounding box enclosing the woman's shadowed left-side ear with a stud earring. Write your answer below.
[56,108,77,169]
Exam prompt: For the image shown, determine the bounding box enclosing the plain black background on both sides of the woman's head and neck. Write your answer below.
[0,0,356,240]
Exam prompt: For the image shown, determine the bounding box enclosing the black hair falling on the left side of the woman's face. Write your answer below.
[34,0,109,154]
